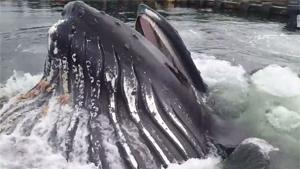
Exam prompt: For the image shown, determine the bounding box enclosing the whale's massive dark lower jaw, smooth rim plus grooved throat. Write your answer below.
[45,2,213,168]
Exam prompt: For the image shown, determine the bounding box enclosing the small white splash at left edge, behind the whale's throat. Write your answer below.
[0,70,42,98]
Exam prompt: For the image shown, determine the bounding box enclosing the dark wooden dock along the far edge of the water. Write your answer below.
[161,0,300,30]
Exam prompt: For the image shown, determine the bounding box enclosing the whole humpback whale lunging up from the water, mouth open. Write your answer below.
[0,1,276,169]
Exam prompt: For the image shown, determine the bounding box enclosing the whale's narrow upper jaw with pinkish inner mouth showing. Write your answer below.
[135,4,207,92]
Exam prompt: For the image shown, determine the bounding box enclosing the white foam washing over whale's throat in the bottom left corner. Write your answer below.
[0,97,103,169]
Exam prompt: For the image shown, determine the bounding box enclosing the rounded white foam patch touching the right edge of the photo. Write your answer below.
[251,65,300,97]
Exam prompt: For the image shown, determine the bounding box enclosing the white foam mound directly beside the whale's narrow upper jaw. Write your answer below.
[191,52,249,116]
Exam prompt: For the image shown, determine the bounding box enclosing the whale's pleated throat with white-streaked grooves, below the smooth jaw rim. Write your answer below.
[35,37,216,168]
